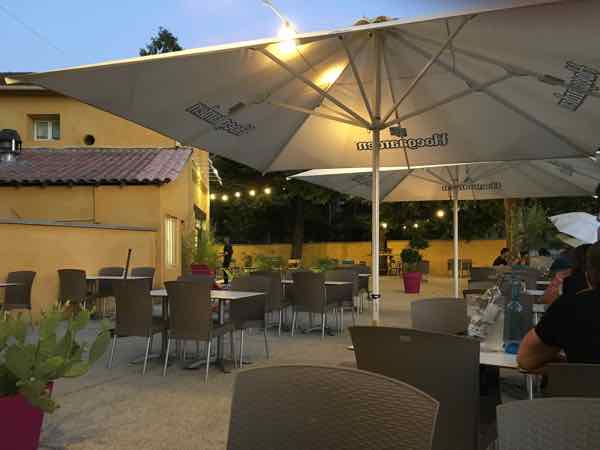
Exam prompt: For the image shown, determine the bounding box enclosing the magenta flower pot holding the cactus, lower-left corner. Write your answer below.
[0,383,52,450]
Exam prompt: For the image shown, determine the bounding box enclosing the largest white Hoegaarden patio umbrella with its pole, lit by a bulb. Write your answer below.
[8,0,600,323]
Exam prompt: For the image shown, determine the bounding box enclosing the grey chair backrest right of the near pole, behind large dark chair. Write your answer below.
[410,298,469,334]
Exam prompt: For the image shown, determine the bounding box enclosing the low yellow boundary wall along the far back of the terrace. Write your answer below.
[233,239,506,276]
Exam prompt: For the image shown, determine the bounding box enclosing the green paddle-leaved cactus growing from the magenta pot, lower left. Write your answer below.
[0,308,110,412]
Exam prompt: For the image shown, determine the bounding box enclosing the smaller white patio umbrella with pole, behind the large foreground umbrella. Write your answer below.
[291,158,600,297]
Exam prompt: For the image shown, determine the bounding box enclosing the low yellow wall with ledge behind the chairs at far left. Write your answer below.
[0,224,156,317]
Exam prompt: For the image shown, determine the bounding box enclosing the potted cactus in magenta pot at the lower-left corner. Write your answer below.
[0,309,110,450]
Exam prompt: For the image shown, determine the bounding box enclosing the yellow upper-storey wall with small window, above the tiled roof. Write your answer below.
[0,91,175,148]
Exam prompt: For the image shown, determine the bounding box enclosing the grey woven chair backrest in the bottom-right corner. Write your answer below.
[497,398,600,450]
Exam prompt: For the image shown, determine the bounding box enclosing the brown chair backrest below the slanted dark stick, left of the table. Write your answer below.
[112,279,153,337]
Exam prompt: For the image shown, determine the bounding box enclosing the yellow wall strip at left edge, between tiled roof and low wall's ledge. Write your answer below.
[0,186,94,222]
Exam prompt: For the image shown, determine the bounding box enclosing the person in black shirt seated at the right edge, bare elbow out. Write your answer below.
[517,243,600,371]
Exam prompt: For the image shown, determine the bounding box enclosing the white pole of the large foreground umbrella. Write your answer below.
[371,128,380,326]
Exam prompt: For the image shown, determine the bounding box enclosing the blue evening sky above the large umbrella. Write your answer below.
[0,0,518,71]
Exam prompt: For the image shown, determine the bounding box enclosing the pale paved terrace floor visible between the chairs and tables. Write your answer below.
[40,277,524,450]
